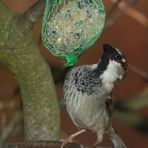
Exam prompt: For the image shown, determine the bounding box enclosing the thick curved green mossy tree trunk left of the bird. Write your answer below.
[0,0,60,141]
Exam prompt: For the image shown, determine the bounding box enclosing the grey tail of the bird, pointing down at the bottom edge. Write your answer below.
[108,126,127,148]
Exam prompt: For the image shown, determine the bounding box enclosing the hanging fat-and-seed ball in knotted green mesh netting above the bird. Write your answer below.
[42,0,105,66]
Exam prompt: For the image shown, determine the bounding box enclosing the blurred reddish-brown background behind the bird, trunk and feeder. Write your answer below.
[0,0,148,148]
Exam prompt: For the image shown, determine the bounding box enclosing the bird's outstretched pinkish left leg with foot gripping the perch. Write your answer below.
[60,129,86,148]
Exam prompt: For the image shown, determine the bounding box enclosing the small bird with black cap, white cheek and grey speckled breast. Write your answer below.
[61,43,127,148]
